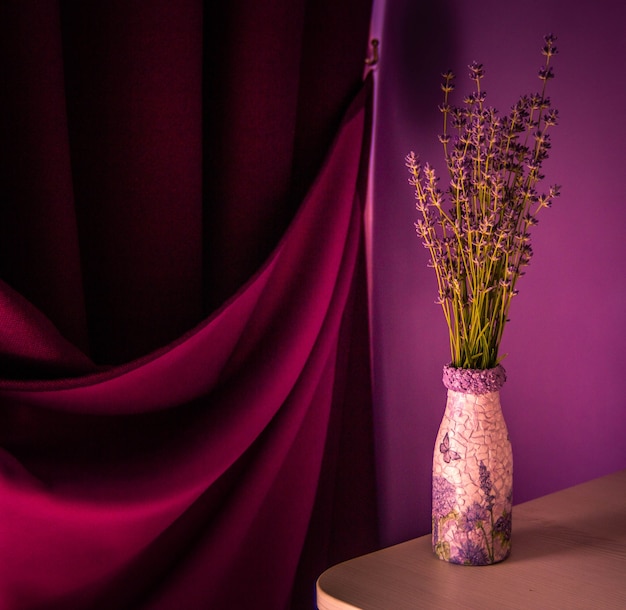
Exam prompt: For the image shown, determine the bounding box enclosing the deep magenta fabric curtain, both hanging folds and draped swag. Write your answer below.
[0,0,376,610]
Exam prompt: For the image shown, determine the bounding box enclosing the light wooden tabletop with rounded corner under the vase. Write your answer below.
[317,470,626,610]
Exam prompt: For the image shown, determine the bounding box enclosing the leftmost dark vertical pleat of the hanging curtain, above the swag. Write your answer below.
[0,2,88,351]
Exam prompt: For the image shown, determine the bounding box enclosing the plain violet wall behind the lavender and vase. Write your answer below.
[371,0,626,544]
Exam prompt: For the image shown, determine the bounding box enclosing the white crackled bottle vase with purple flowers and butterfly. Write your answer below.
[432,366,513,565]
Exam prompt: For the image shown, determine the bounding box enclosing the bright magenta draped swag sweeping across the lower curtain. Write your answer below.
[0,75,373,608]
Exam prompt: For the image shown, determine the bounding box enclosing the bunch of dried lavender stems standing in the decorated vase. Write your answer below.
[406,34,559,369]
